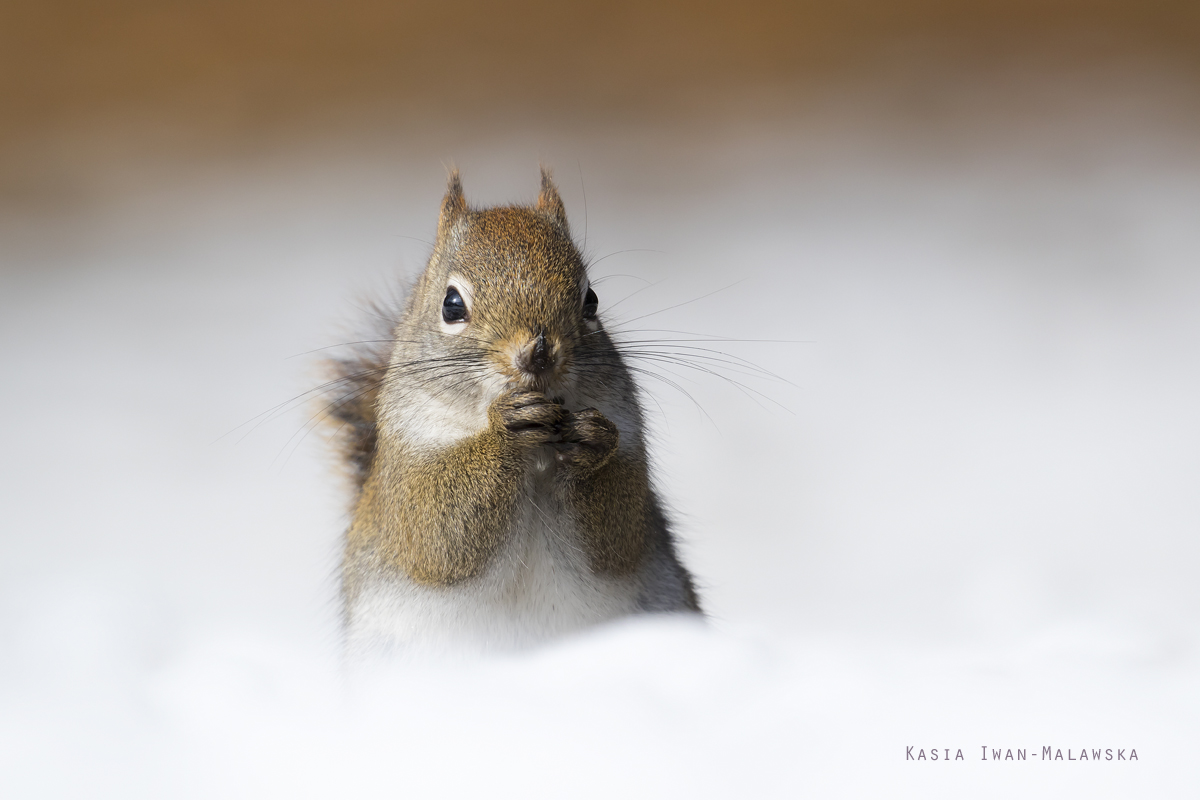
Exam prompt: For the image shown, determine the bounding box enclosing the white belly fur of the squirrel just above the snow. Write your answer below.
[347,497,638,656]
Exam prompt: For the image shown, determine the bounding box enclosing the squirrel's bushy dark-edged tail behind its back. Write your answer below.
[320,306,397,497]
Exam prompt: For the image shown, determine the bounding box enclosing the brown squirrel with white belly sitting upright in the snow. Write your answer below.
[329,168,701,655]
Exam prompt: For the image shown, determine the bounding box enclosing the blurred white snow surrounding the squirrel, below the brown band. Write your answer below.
[0,65,1200,798]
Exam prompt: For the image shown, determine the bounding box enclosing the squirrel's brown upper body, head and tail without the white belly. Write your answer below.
[330,172,698,652]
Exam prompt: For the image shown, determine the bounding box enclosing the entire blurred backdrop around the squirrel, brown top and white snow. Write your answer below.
[0,0,1200,796]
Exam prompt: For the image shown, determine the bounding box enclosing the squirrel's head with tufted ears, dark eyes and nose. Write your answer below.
[409,169,600,391]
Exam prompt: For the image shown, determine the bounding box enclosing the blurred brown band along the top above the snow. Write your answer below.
[0,0,1200,211]
